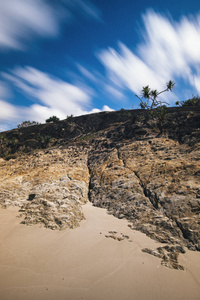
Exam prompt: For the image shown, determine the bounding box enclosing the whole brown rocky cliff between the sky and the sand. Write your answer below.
[0,107,200,268]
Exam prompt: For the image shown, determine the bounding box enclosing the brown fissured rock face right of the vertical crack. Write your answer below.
[89,138,200,250]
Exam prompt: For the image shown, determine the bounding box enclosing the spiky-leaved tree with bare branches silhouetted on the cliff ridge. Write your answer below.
[136,80,175,109]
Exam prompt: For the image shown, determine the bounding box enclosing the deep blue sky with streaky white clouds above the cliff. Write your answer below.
[0,0,200,131]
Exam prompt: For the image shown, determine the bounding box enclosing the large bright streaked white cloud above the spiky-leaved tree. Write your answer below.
[97,10,200,97]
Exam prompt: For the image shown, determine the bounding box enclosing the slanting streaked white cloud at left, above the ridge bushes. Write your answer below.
[3,67,90,118]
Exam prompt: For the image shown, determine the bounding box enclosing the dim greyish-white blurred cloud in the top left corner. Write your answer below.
[0,0,100,50]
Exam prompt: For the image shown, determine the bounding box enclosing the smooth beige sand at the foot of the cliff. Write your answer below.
[0,203,200,300]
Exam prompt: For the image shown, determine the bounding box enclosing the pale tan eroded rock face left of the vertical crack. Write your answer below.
[0,148,89,229]
